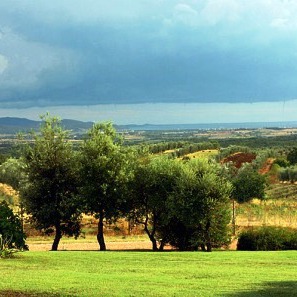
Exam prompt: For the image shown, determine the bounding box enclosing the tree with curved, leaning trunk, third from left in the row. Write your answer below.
[130,157,181,251]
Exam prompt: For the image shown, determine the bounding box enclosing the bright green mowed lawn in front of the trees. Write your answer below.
[0,251,297,297]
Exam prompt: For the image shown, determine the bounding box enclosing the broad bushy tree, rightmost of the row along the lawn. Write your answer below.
[169,159,232,251]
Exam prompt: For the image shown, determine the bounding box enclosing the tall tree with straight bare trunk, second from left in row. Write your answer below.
[80,123,132,251]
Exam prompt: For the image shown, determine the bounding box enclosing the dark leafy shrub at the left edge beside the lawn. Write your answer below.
[0,201,27,255]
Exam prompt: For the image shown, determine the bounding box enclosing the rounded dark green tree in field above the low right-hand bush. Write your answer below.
[232,165,266,203]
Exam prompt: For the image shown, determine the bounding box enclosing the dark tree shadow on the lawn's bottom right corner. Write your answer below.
[225,281,297,297]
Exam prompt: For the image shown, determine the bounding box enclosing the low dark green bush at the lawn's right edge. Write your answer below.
[237,227,297,251]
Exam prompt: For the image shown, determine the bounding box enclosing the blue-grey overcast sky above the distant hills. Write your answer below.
[0,0,297,123]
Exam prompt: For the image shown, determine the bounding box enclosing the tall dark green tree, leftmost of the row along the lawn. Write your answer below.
[21,115,80,250]
